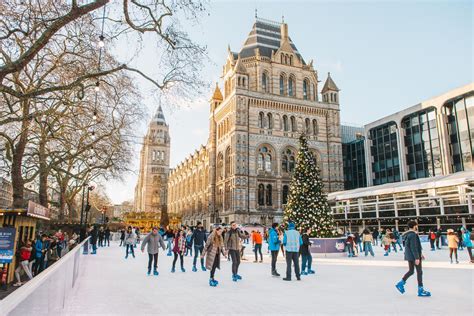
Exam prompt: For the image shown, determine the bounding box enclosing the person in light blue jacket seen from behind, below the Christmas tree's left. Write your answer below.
[283,222,303,281]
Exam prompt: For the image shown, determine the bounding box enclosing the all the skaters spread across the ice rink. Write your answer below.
[81,221,473,296]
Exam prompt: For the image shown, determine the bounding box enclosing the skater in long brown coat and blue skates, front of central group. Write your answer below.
[201,226,226,287]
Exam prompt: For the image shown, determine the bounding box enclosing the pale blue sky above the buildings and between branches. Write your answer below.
[106,0,474,203]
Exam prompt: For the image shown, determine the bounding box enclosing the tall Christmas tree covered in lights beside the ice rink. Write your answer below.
[284,135,335,237]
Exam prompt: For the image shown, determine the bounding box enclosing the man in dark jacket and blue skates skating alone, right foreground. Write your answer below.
[395,221,431,296]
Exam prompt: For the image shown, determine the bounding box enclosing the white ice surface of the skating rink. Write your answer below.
[65,243,474,315]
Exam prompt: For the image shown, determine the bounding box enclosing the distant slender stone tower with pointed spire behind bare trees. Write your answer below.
[134,105,170,212]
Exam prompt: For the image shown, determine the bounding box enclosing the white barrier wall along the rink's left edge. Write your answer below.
[0,238,89,316]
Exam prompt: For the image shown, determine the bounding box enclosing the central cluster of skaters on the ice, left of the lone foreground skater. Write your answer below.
[115,222,315,287]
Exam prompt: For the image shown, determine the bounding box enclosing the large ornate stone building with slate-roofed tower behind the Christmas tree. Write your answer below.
[168,19,344,230]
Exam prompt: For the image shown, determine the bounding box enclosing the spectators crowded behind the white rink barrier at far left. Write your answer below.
[13,229,79,287]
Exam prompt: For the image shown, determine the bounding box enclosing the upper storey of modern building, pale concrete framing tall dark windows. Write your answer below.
[365,84,474,186]
